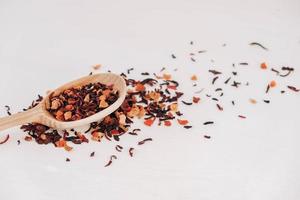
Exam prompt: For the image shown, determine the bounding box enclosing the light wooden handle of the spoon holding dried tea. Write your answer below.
[0,105,41,131]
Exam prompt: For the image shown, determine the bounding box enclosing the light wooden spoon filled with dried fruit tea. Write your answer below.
[0,73,126,131]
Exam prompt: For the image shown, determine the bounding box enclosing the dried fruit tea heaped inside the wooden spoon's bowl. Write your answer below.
[47,82,119,121]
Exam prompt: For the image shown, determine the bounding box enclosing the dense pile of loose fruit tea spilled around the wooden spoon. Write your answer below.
[21,74,188,148]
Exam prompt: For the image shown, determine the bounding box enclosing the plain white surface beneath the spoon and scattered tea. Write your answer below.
[0,0,300,200]
